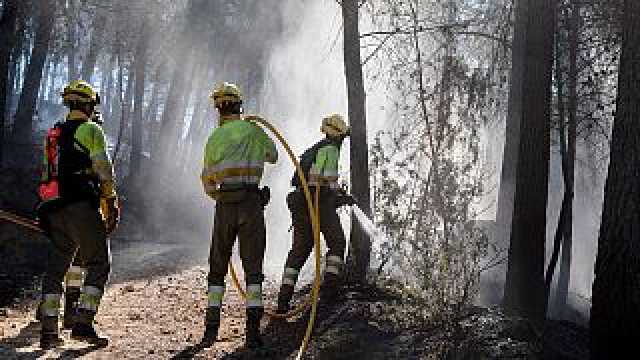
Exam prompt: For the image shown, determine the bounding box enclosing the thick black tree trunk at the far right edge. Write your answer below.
[590,0,640,360]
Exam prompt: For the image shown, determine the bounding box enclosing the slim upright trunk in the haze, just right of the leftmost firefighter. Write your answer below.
[129,21,148,188]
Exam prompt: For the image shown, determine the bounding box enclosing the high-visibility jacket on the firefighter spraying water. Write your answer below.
[291,138,341,189]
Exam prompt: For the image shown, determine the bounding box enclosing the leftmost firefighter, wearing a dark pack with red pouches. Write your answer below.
[38,80,120,349]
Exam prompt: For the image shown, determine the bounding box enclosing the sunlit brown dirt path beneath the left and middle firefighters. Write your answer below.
[0,267,302,359]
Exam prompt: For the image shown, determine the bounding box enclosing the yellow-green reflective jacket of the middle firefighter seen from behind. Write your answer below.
[201,118,278,196]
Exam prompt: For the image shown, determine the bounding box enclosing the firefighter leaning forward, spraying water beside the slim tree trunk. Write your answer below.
[277,114,354,314]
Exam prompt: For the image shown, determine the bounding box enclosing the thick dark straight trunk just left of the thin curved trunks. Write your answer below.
[504,0,556,326]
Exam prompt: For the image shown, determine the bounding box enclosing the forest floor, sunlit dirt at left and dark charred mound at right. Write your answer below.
[0,240,588,360]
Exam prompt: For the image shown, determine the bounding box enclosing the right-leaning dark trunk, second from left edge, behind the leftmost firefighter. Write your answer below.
[13,0,56,151]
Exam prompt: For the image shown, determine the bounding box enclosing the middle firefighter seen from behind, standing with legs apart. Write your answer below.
[201,83,278,348]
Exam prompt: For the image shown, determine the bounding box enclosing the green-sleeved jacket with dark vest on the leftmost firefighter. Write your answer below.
[41,111,116,198]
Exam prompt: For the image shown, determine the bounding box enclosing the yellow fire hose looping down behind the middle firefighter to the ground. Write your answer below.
[229,116,320,360]
